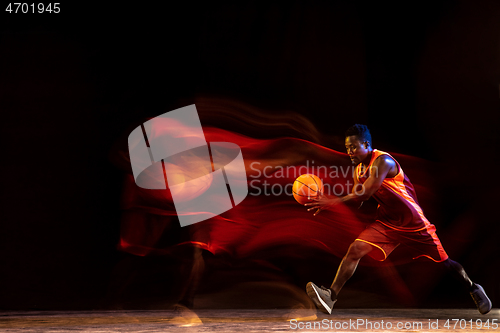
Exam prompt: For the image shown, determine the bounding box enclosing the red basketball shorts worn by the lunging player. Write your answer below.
[356,221,448,262]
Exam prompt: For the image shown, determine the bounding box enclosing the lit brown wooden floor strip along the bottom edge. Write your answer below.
[0,309,500,332]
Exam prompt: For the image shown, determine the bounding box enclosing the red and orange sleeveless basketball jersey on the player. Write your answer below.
[356,149,432,231]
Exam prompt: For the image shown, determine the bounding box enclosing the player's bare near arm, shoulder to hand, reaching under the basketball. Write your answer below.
[305,155,397,215]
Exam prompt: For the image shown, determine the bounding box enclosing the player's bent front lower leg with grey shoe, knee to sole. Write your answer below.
[306,240,373,314]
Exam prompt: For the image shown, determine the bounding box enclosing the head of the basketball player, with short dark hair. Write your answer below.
[345,124,372,164]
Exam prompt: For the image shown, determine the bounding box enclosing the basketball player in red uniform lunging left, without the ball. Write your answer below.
[305,124,491,314]
